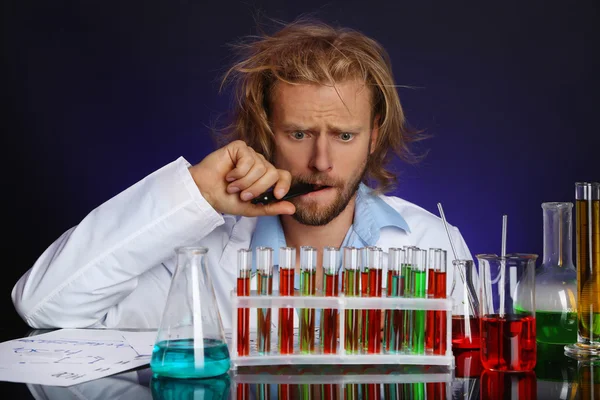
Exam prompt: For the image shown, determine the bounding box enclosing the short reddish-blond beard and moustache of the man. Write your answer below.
[289,162,367,226]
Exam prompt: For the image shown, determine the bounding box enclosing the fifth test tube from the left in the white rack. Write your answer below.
[321,247,340,354]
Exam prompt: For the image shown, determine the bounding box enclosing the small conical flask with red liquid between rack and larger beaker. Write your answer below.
[450,260,480,350]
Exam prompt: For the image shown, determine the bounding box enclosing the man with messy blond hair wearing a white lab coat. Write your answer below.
[12,23,471,328]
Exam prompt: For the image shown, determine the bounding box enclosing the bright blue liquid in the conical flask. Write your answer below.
[150,339,230,378]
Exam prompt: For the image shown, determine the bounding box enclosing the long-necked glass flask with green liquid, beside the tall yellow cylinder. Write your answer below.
[535,203,577,344]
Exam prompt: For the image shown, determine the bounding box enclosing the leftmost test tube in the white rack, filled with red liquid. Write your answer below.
[236,249,252,356]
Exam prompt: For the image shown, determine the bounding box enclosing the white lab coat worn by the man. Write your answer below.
[12,158,471,330]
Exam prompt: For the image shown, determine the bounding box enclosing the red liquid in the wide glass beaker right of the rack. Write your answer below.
[481,314,537,371]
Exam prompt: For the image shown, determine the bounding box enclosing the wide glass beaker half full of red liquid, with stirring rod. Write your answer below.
[477,254,537,372]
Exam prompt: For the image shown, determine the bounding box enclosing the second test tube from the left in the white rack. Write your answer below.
[256,247,273,354]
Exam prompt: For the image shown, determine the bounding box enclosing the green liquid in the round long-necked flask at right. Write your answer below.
[535,311,577,344]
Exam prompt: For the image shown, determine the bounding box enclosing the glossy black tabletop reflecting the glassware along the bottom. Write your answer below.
[0,332,600,400]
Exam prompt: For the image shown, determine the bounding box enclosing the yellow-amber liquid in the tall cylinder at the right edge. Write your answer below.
[576,200,600,344]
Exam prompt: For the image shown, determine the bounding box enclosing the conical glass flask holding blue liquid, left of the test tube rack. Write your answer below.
[150,247,230,378]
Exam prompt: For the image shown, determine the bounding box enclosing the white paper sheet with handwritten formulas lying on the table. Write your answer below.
[0,329,150,386]
